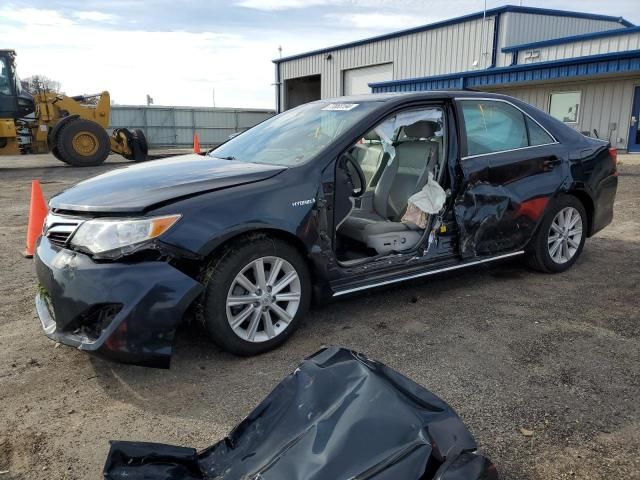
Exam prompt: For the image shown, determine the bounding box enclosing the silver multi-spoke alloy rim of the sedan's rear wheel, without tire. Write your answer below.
[547,207,582,264]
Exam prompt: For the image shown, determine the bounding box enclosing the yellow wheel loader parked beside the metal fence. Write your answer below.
[0,50,148,167]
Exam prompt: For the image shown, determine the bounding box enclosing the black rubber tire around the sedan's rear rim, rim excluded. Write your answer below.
[527,195,587,273]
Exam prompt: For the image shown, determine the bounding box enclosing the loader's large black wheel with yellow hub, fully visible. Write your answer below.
[56,119,111,167]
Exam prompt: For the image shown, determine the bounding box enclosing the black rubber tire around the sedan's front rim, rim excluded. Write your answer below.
[200,234,311,356]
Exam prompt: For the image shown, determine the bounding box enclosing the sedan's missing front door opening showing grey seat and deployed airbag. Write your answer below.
[335,107,446,262]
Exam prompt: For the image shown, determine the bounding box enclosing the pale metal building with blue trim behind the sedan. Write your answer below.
[274,5,640,151]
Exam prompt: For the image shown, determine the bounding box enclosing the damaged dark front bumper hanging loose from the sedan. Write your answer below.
[34,237,203,368]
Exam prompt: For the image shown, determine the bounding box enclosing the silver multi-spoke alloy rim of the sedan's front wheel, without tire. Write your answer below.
[226,256,302,343]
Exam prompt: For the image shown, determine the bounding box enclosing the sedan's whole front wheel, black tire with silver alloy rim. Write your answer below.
[202,235,311,356]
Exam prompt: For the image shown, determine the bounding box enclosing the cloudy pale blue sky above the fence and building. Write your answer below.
[0,0,640,108]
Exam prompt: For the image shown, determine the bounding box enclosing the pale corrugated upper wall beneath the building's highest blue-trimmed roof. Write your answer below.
[280,12,624,108]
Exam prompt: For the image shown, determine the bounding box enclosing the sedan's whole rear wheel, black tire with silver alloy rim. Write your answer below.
[528,195,587,273]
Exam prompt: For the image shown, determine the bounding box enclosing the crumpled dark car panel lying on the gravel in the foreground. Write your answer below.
[104,347,498,480]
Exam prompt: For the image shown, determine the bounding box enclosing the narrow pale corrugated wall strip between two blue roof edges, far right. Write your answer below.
[518,32,640,64]
